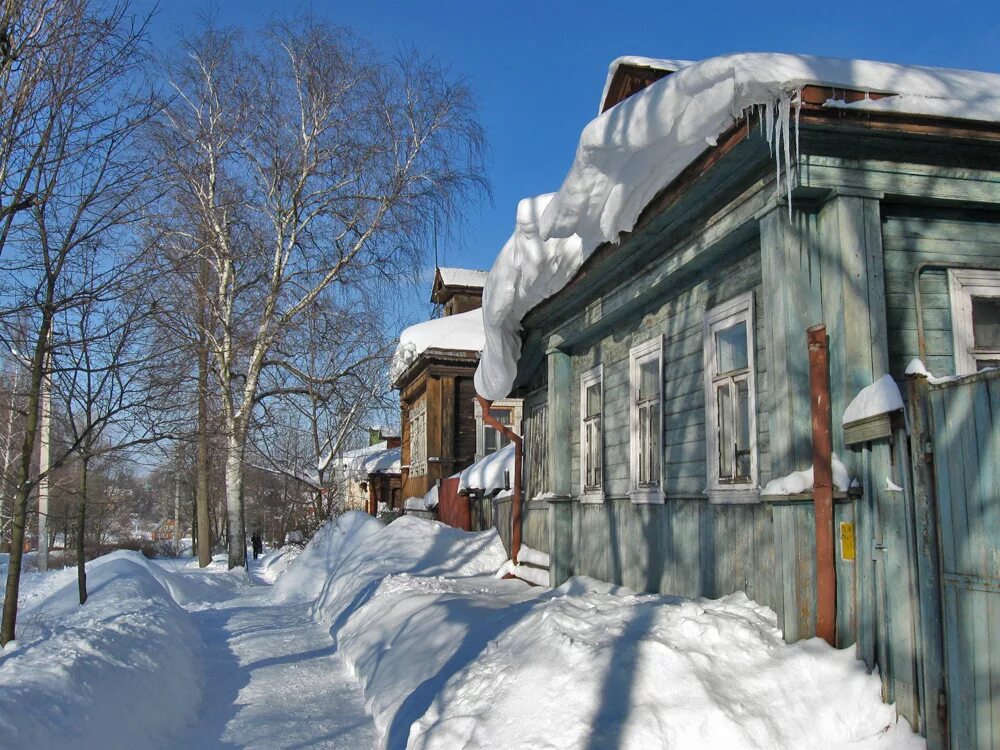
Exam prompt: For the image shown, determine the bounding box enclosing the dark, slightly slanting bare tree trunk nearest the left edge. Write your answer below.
[0,314,54,646]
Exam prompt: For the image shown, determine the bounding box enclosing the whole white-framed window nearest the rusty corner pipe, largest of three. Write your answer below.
[704,293,757,502]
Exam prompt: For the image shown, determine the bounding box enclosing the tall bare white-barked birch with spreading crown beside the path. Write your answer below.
[149,17,484,567]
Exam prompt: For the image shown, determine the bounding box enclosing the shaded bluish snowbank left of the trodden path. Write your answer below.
[0,553,202,750]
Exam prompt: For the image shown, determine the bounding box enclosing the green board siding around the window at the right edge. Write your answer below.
[882,208,1000,378]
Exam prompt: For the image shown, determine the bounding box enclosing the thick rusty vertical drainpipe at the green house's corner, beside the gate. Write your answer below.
[807,324,837,646]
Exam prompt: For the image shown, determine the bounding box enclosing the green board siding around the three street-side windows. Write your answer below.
[570,247,770,499]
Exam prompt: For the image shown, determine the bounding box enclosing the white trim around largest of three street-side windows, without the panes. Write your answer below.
[702,292,760,503]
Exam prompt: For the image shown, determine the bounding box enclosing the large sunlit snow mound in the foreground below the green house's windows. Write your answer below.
[408,591,923,750]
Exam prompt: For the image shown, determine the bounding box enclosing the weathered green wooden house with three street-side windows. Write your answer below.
[476,54,1000,748]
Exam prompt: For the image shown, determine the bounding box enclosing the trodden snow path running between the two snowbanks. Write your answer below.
[171,568,375,750]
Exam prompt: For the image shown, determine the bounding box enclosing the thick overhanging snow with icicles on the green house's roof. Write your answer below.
[476,53,1000,399]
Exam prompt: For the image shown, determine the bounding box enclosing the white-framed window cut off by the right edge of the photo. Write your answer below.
[948,268,1000,375]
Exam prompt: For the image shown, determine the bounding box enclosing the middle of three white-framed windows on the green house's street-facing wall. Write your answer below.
[629,336,663,502]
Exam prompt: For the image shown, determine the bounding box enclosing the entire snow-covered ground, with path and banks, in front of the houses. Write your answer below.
[0,513,923,750]
